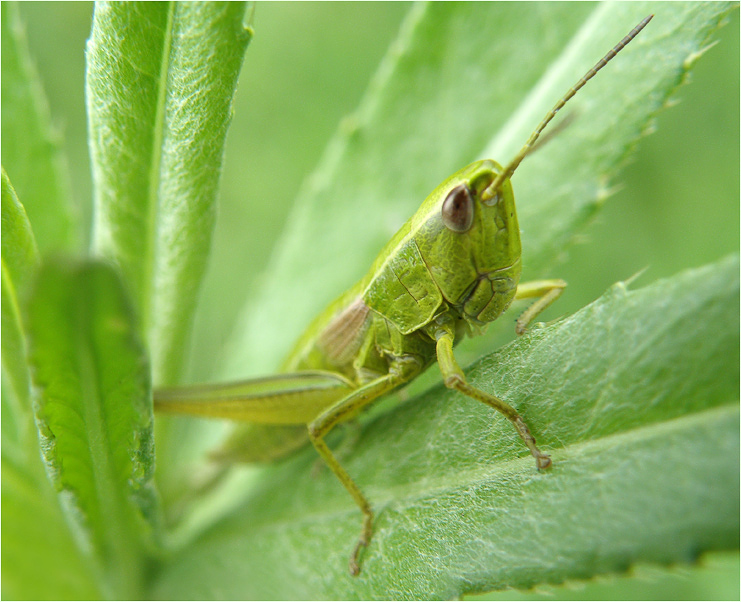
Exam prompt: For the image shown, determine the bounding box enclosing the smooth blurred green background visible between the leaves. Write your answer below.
[11,2,739,599]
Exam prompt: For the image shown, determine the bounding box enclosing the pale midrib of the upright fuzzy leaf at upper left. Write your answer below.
[142,2,175,332]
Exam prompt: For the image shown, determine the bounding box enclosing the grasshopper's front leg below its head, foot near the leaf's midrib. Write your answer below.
[437,330,551,470]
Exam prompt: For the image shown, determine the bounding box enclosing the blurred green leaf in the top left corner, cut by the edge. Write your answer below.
[1,2,77,251]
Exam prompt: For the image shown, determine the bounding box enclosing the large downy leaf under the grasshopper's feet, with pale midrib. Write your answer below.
[154,258,739,599]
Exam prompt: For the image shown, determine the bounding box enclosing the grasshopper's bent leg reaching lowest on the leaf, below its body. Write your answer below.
[309,358,421,575]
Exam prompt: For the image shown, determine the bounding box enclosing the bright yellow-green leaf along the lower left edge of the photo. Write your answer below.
[2,168,100,600]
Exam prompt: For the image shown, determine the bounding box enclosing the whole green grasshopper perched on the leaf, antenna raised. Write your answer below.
[154,15,653,575]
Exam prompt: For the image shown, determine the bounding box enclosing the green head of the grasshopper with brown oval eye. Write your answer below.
[412,159,521,325]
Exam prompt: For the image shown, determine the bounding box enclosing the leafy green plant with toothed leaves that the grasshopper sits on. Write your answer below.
[2,4,739,598]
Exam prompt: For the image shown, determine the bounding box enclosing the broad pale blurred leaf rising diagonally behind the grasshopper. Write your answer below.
[220,3,732,378]
